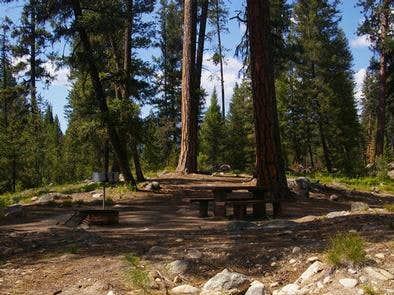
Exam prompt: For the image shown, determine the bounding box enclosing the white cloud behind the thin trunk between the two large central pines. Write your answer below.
[201,53,242,112]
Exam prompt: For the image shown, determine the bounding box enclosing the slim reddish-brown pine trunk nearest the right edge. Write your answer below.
[375,0,389,159]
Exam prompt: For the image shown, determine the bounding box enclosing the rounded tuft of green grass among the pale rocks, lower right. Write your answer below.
[326,233,366,266]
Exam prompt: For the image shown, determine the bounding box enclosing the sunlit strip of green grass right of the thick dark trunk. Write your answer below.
[288,172,394,194]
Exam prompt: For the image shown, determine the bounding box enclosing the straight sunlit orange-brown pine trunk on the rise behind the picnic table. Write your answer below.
[176,0,198,173]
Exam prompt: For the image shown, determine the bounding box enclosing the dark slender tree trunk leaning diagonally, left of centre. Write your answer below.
[71,0,136,185]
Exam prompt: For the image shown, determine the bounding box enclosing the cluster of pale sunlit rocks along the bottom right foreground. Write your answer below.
[167,252,394,295]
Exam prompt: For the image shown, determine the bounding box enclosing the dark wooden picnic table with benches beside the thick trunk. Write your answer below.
[190,185,268,219]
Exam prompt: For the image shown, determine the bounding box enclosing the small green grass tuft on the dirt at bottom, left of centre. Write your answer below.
[124,253,151,294]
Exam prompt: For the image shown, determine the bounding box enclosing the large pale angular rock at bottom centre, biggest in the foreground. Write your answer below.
[202,269,250,294]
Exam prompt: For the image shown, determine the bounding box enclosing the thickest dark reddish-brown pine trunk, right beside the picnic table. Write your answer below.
[247,0,289,216]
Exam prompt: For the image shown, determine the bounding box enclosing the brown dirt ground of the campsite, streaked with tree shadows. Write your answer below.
[0,174,394,295]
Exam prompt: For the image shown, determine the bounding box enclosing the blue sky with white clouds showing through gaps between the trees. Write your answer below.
[0,0,372,131]
